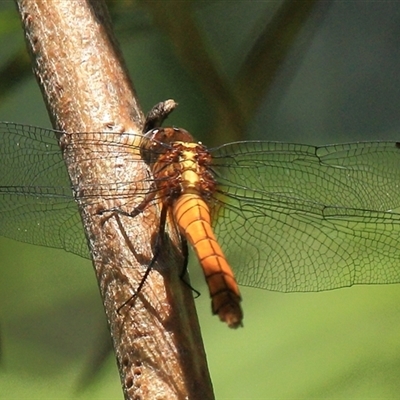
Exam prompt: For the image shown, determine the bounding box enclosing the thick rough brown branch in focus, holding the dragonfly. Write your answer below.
[16,0,213,399]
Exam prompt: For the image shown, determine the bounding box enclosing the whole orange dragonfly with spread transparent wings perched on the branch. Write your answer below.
[0,122,400,328]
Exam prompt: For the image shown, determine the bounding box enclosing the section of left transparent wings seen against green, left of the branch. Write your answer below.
[0,123,89,258]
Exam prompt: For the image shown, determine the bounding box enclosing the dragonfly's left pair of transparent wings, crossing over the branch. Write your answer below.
[0,122,152,258]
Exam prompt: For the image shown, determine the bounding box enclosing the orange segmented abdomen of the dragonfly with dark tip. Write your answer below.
[173,194,243,328]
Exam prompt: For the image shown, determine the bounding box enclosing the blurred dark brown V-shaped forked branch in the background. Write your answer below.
[142,0,318,145]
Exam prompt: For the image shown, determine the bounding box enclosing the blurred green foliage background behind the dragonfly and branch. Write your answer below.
[0,0,400,399]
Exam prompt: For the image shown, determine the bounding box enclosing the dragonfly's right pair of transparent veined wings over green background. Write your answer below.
[212,142,400,292]
